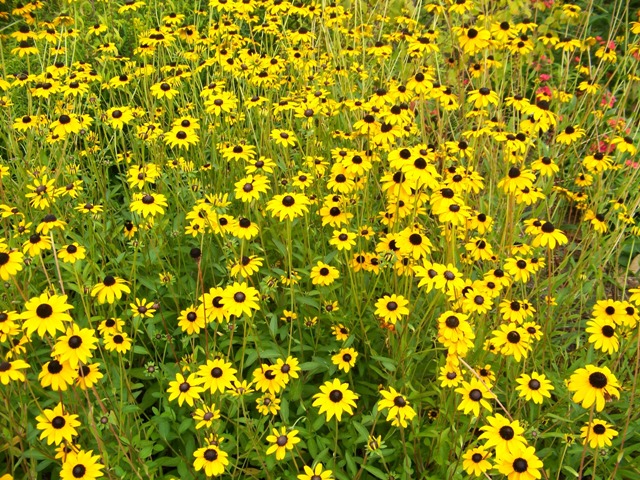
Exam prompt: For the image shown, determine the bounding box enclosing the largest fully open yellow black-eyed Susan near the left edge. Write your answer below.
[20,293,73,338]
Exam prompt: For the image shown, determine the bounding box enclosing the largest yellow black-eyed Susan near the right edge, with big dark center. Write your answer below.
[568,365,620,412]
